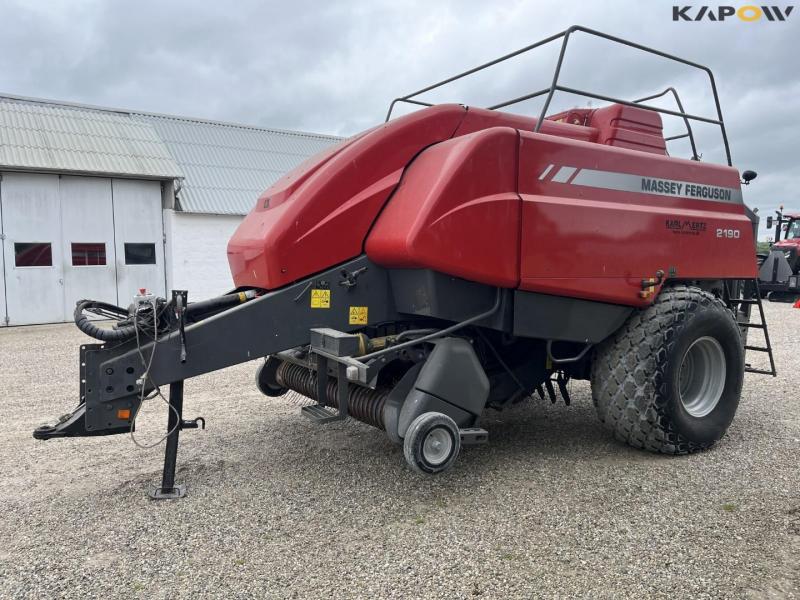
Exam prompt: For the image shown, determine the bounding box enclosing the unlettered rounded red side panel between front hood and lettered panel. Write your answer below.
[366,127,520,287]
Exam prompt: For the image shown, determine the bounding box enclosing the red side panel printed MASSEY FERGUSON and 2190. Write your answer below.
[519,132,756,305]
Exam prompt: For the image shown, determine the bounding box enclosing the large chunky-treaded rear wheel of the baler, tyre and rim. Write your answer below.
[592,285,744,454]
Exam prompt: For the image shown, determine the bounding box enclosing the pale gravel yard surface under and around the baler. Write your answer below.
[0,303,800,598]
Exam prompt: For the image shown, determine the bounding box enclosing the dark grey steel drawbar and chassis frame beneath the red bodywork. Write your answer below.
[37,256,644,439]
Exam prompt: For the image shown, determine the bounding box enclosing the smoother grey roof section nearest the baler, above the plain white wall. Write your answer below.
[133,113,342,215]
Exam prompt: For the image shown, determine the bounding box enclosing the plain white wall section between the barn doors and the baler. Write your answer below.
[164,210,244,302]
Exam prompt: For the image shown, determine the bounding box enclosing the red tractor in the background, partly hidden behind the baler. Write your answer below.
[758,206,800,302]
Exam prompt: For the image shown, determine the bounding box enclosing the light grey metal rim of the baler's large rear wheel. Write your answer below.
[678,336,726,418]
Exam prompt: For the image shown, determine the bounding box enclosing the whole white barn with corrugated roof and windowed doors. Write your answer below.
[0,94,342,325]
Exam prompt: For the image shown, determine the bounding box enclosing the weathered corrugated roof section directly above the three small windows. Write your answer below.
[0,97,183,179]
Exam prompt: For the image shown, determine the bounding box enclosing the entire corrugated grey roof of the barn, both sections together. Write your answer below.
[0,95,343,215]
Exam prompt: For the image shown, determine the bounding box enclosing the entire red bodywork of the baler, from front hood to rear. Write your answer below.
[228,105,756,305]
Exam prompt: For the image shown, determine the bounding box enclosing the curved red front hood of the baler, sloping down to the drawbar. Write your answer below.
[228,104,466,289]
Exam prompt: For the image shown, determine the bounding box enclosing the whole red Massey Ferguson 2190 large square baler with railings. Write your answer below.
[34,27,774,497]
